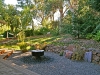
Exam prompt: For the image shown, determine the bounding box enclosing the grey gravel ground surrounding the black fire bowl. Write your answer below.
[7,52,100,75]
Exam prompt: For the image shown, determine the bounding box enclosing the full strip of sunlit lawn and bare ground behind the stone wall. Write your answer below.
[0,34,100,50]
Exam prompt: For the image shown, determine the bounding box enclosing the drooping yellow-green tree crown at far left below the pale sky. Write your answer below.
[5,5,19,33]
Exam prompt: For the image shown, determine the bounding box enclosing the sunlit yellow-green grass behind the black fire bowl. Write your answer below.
[0,35,65,50]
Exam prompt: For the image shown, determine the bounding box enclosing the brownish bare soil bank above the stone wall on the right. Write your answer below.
[53,35,100,50]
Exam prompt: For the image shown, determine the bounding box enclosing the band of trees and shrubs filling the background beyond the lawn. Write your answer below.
[0,0,100,42]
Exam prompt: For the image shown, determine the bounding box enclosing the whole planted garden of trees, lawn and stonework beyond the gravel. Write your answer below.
[0,0,100,64]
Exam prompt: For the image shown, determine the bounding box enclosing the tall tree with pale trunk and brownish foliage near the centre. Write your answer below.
[45,0,69,33]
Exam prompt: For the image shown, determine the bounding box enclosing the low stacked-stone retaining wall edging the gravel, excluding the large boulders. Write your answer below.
[45,45,100,64]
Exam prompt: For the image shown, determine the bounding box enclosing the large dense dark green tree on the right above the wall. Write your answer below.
[64,0,100,38]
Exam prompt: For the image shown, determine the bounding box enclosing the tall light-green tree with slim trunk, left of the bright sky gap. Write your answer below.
[17,0,37,34]
